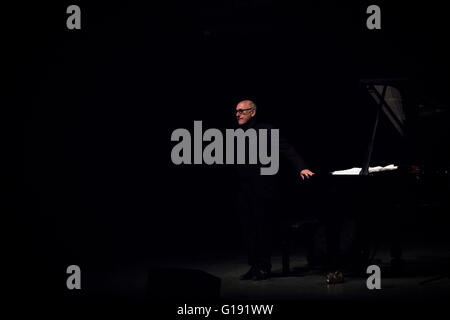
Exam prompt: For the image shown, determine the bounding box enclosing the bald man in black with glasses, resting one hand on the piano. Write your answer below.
[236,100,314,280]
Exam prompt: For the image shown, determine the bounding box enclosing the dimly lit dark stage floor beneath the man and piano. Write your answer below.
[75,242,450,301]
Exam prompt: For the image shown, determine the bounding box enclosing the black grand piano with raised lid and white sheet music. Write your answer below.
[282,78,450,275]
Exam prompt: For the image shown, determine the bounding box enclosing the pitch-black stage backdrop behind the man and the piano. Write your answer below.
[1,0,450,298]
